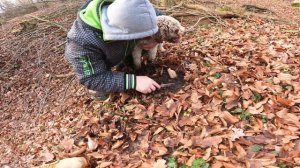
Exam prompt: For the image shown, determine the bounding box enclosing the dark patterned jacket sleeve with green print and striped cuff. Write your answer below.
[65,40,136,92]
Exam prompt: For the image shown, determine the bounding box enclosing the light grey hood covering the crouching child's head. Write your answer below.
[101,0,158,40]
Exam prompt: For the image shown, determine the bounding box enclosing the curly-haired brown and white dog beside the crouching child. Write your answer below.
[132,15,185,69]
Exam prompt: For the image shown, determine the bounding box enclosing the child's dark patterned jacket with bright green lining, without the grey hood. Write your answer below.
[65,0,161,92]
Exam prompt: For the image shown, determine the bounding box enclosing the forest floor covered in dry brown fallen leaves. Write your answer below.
[0,0,300,168]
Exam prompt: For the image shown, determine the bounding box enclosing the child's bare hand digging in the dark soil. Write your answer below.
[136,76,160,94]
